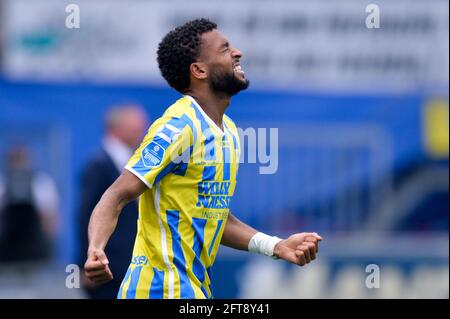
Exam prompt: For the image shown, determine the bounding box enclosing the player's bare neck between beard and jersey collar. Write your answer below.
[185,89,231,129]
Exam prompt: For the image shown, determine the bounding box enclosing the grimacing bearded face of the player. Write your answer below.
[201,30,250,96]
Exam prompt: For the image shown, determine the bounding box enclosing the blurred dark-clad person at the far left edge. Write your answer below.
[0,146,59,262]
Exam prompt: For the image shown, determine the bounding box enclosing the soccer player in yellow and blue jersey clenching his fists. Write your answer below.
[85,19,322,299]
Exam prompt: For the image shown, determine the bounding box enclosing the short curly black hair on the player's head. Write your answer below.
[157,18,217,93]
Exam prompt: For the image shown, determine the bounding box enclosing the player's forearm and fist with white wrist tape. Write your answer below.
[221,213,322,266]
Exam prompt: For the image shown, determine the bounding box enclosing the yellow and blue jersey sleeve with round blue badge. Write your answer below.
[125,117,194,188]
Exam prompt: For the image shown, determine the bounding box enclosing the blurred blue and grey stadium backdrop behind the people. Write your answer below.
[0,0,449,298]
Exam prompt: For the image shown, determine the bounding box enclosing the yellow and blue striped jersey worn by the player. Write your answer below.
[118,96,240,299]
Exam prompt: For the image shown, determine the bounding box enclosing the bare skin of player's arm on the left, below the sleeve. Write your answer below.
[84,170,147,283]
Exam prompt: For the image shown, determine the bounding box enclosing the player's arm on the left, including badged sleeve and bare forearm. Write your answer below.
[84,117,195,283]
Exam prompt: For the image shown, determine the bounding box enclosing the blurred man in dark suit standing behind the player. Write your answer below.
[78,105,149,299]
